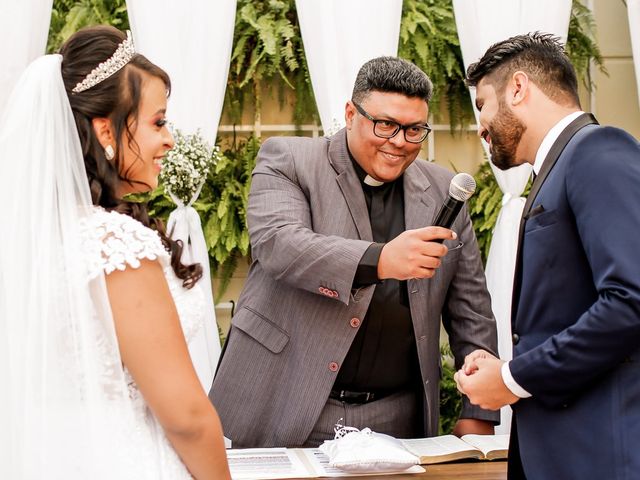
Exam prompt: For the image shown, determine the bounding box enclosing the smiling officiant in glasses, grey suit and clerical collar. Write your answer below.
[210,57,498,447]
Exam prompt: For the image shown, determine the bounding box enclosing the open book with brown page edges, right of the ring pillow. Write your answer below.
[400,434,509,465]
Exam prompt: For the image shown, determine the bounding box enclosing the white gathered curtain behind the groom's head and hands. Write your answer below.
[453,0,571,433]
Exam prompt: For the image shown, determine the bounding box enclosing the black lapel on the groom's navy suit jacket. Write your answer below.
[511,113,598,322]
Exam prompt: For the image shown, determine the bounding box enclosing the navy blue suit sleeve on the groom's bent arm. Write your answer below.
[510,127,640,406]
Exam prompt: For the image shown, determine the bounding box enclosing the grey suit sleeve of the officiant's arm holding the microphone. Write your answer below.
[247,137,371,304]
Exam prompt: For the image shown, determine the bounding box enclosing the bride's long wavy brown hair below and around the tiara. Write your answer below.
[60,25,202,288]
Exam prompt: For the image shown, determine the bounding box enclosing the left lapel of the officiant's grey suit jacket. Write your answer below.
[329,128,373,241]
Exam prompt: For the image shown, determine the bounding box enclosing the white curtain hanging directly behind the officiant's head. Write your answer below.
[296,0,402,135]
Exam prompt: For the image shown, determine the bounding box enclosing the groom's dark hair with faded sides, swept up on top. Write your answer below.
[467,32,580,106]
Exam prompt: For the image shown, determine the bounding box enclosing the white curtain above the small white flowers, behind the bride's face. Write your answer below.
[127,0,236,144]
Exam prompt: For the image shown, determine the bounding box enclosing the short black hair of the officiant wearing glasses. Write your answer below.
[351,56,433,103]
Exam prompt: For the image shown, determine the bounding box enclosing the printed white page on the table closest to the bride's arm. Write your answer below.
[227,448,317,480]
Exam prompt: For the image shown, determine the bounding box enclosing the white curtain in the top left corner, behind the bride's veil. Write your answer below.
[0,0,53,115]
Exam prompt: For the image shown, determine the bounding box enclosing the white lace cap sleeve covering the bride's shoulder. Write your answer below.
[80,208,169,277]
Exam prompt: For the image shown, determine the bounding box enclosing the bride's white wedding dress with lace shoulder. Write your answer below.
[81,208,204,480]
